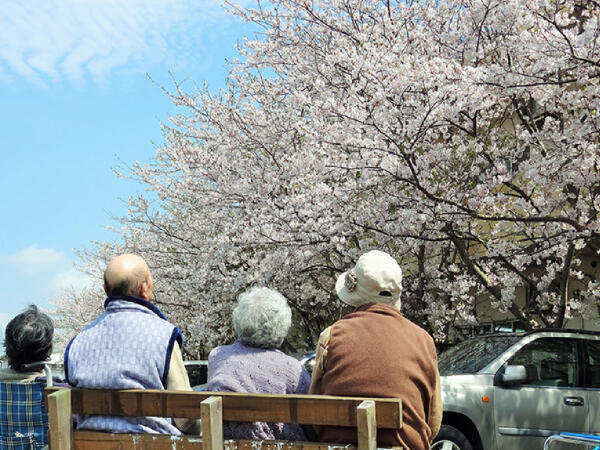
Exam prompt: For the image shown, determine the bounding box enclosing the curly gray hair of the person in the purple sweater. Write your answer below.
[233,287,292,348]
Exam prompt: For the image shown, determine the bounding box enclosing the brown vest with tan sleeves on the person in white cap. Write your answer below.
[311,304,441,450]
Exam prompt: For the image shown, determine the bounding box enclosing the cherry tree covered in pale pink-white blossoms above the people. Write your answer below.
[54,0,600,354]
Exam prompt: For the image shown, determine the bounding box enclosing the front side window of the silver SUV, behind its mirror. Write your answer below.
[508,338,578,387]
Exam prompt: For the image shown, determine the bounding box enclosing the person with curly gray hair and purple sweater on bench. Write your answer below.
[207,287,310,441]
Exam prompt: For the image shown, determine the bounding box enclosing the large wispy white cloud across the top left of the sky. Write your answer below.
[0,0,248,83]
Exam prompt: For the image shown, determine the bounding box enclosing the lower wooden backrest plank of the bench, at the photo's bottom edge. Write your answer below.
[73,431,356,450]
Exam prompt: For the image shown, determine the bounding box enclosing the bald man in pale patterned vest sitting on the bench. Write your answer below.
[65,254,200,435]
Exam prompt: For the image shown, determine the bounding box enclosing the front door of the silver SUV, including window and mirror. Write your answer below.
[494,337,588,450]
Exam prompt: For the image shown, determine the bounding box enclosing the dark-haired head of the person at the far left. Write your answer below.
[4,305,54,372]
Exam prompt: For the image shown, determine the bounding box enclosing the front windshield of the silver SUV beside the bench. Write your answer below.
[438,335,520,376]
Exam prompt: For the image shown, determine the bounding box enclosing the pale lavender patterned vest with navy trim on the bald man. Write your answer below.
[65,296,183,435]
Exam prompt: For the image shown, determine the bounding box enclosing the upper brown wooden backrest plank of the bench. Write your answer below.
[47,388,402,429]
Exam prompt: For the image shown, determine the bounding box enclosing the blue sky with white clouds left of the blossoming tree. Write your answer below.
[0,0,252,335]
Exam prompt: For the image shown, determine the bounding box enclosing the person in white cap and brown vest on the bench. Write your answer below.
[310,250,442,450]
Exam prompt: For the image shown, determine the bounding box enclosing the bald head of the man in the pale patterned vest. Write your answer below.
[104,253,150,297]
